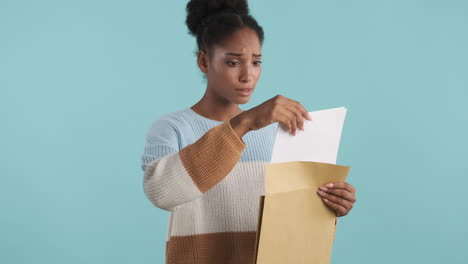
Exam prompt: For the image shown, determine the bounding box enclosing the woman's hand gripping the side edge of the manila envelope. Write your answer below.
[317,182,356,217]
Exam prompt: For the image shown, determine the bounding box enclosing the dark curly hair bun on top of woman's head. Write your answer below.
[185,0,249,36]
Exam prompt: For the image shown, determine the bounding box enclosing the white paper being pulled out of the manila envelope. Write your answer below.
[271,107,346,164]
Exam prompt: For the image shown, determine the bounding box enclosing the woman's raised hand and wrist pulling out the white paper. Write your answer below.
[231,95,312,137]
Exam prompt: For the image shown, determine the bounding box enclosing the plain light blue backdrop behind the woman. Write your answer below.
[0,0,468,264]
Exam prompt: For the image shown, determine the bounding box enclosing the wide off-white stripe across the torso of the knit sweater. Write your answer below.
[168,161,267,238]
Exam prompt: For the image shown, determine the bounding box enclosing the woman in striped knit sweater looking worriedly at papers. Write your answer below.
[142,0,355,263]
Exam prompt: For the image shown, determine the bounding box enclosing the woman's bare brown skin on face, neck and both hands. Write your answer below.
[191,28,356,217]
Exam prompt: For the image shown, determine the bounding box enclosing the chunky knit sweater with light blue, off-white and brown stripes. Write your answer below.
[141,108,278,264]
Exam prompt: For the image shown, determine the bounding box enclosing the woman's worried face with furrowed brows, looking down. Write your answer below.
[199,28,262,104]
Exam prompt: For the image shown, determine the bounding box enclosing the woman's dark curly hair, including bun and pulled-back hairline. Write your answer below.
[185,0,264,55]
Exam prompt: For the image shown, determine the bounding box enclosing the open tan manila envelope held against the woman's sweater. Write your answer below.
[255,161,351,264]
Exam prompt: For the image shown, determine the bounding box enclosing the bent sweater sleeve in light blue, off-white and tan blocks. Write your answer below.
[142,117,246,211]
